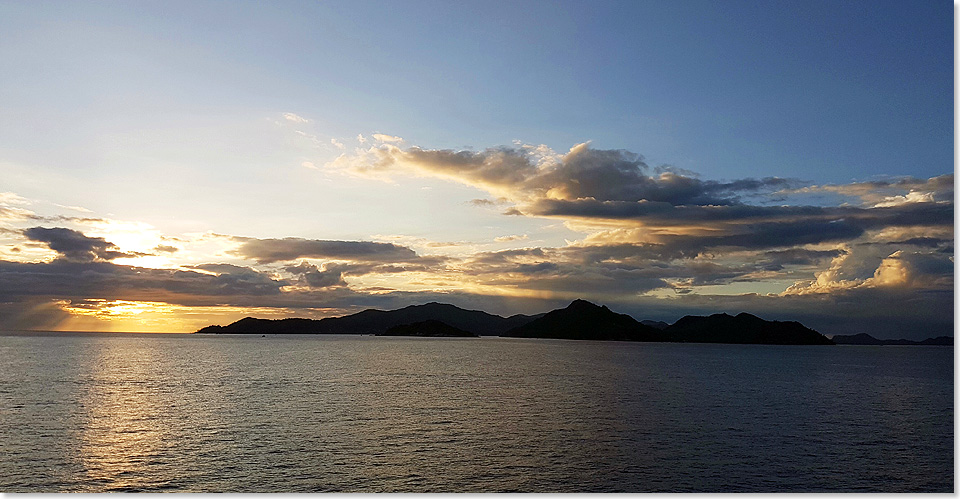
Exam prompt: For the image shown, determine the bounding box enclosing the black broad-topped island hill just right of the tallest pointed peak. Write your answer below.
[664,312,834,345]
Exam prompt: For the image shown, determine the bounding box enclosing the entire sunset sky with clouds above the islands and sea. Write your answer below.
[0,0,955,339]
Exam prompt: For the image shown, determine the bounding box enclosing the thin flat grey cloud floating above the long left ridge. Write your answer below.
[236,237,419,263]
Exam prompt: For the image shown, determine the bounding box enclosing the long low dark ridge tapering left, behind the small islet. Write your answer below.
[197,302,539,335]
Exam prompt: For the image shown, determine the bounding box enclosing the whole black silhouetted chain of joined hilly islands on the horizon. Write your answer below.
[197,300,848,345]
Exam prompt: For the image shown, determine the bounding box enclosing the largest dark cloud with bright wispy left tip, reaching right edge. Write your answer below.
[342,144,953,255]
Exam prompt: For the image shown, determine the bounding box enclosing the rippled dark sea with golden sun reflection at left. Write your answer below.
[0,334,954,492]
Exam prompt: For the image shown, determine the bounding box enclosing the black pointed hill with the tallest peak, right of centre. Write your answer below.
[501,300,669,341]
